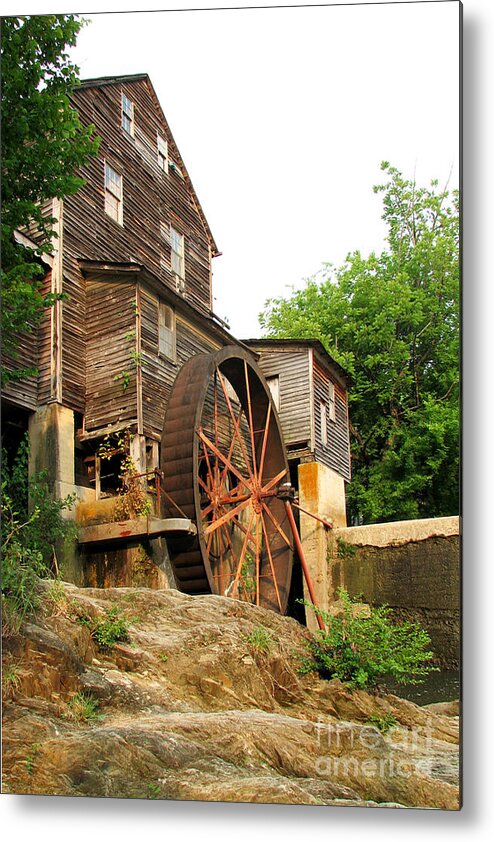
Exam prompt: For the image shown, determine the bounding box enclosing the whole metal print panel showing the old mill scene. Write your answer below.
[2,2,461,811]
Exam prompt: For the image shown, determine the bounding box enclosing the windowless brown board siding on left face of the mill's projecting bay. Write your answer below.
[85,280,138,432]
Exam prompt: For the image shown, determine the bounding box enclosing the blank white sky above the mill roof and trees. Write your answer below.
[59,2,459,338]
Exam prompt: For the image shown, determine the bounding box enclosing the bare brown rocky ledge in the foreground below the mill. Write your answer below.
[3,583,459,810]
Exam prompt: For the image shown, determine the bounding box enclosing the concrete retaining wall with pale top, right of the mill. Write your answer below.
[330,518,460,669]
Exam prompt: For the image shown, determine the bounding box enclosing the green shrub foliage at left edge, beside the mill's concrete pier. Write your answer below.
[2,437,75,634]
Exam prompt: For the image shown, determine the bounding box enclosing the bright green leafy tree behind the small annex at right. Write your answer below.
[260,162,459,522]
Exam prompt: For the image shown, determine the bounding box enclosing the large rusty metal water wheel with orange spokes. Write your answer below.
[161,346,292,614]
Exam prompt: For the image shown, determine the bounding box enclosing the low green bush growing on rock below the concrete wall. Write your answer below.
[300,589,436,688]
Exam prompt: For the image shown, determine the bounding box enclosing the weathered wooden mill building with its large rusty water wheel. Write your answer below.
[2,74,350,612]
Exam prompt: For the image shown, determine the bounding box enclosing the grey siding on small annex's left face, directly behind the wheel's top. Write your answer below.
[253,349,311,449]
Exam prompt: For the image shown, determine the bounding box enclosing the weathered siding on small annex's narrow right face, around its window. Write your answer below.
[313,355,351,480]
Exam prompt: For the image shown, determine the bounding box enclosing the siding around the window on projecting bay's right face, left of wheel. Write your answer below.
[140,286,220,439]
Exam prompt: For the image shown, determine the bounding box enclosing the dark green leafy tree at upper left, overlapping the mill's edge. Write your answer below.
[1,15,98,379]
